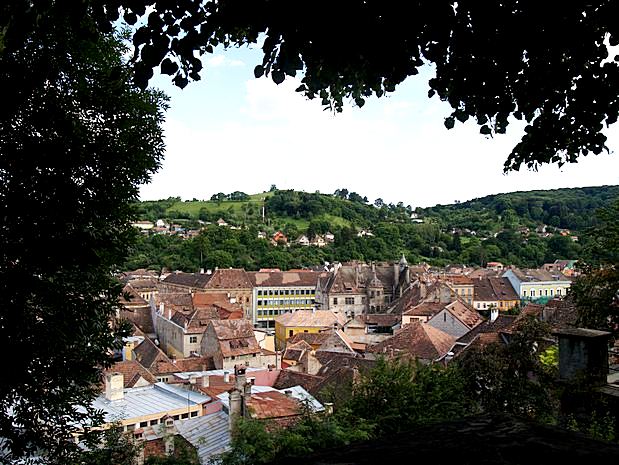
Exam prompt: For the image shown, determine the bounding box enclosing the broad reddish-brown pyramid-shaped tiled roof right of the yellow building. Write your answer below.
[368,321,456,360]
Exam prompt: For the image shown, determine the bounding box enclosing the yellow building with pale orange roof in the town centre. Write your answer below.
[275,310,345,350]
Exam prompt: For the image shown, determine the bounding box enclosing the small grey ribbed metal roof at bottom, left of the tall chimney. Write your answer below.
[174,411,230,464]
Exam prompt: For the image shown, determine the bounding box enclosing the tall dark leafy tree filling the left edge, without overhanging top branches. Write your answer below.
[0,8,164,462]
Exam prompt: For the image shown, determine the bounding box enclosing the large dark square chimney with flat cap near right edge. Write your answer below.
[553,328,610,386]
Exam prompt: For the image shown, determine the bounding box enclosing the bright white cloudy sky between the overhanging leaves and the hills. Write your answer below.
[140,47,619,208]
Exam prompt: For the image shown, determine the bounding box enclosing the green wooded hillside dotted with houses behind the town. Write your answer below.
[125,186,619,271]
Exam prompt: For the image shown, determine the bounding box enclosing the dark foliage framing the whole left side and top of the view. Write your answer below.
[0,0,619,458]
